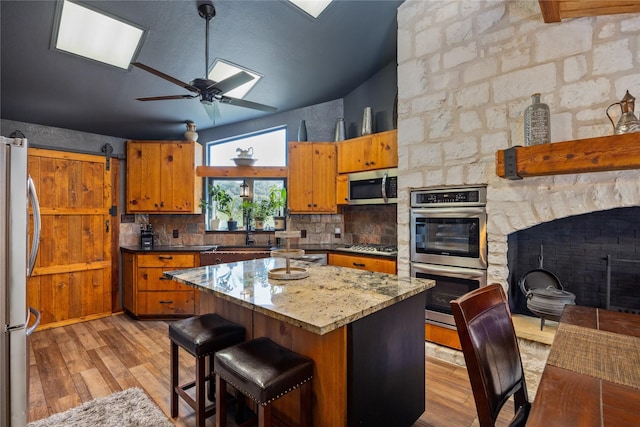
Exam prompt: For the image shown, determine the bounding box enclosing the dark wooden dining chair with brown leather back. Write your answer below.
[451,283,531,427]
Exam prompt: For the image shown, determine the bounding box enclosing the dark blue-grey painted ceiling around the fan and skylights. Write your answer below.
[0,0,402,139]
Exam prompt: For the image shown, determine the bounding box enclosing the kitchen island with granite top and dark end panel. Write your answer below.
[164,258,435,427]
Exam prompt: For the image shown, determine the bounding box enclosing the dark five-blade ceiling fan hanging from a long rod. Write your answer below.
[131,3,277,120]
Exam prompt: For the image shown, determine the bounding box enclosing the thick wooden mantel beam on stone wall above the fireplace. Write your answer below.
[496,133,640,178]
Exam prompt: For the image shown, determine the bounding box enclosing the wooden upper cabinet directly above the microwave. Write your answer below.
[338,129,398,173]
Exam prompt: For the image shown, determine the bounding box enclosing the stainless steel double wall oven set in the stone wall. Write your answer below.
[410,186,487,329]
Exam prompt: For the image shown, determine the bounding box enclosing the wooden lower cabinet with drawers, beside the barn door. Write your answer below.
[122,252,198,318]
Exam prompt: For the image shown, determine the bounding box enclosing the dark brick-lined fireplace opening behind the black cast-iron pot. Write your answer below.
[507,206,640,316]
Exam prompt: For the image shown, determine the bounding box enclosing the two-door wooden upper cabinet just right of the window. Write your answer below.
[287,142,338,213]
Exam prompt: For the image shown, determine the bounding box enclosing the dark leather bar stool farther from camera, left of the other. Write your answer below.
[169,313,245,427]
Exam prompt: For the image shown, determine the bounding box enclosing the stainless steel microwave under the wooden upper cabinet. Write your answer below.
[348,168,398,205]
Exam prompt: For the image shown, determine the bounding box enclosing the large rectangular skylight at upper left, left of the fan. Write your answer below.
[54,0,144,69]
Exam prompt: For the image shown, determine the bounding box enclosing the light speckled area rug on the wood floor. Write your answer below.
[27,387,174,427]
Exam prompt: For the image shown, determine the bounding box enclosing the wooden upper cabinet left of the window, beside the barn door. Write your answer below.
[127,141,202,214]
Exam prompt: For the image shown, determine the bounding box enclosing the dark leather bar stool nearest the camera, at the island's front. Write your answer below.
[214,338,313,427]
